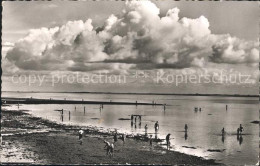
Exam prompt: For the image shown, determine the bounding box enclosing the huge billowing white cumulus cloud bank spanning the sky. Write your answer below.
[2,1,259,72]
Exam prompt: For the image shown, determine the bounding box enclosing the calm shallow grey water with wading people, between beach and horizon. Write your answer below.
[2,92,259,165]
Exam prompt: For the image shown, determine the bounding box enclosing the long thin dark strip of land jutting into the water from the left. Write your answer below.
[1,97,164,106]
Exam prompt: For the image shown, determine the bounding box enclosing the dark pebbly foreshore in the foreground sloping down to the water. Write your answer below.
[1,110,220,165]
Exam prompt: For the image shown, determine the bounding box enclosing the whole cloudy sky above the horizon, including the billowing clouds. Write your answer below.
[2,1,259,94]
